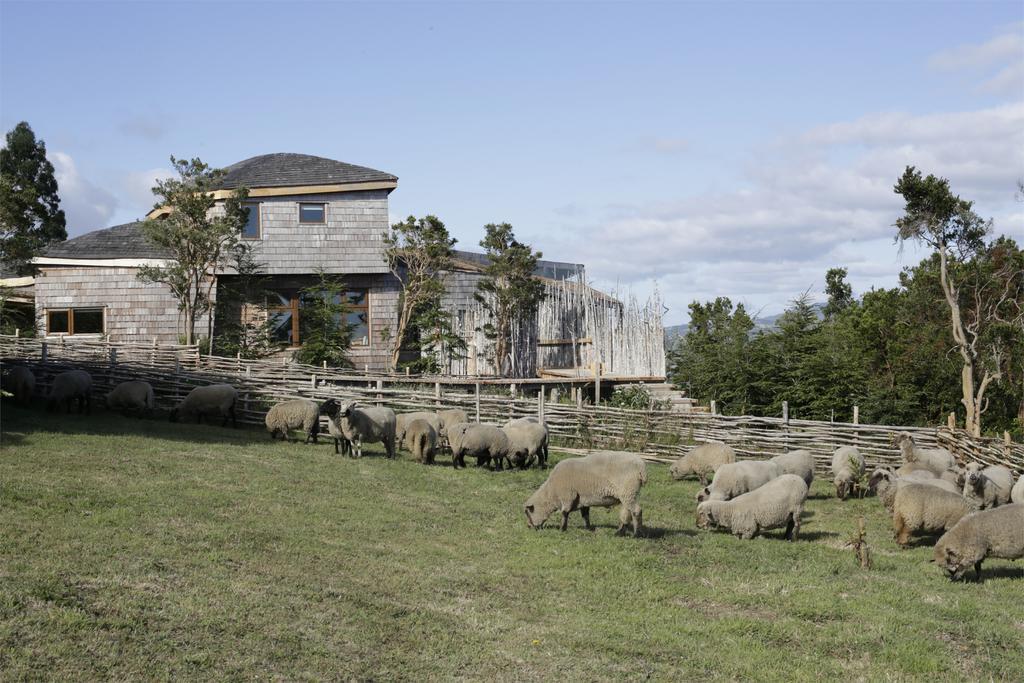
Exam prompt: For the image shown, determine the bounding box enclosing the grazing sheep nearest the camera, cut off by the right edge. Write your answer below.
[933,503,1024,582]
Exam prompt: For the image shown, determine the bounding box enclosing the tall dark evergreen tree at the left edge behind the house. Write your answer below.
[0,121,68,274]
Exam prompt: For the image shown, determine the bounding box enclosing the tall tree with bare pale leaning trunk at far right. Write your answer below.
[893,166,1019,436]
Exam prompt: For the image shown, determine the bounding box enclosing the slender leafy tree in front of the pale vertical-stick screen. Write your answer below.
[473,223,545,377]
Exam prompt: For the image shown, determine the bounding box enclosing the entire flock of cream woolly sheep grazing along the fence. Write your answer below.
[4,366,1024,580]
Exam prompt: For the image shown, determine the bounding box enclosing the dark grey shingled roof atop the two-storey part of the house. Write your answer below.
[221,153,398,189]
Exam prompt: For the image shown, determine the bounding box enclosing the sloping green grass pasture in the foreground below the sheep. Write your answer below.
[0,404,1024,681]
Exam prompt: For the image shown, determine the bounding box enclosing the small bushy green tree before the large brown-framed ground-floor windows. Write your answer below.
[294,270,355,368]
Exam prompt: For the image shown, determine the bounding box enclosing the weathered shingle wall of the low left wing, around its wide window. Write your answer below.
[36,266,207,344]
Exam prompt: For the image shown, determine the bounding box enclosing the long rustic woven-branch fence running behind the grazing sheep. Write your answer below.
[0,336,1024,474]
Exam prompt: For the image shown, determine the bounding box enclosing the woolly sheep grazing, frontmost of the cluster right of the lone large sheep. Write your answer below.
[696,474,807,541]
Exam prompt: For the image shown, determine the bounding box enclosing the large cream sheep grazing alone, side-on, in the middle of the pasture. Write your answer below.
[523,451,647,537]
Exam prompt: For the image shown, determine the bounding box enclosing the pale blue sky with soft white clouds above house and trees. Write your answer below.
[0,1,1024,324]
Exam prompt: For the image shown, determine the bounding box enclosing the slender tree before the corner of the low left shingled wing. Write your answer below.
[138,157,249,344]
